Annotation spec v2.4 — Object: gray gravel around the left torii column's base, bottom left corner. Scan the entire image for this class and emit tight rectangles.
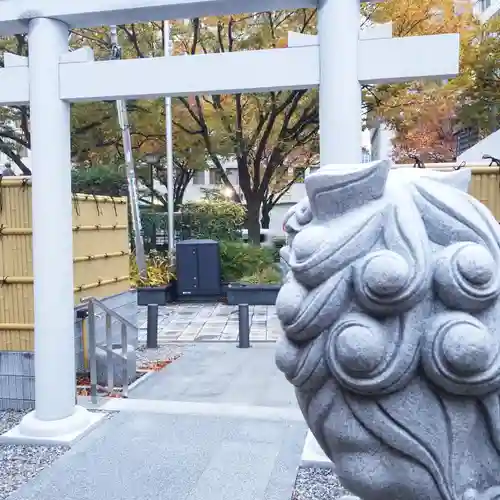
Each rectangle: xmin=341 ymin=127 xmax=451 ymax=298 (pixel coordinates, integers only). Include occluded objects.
xmin=0 ymin=411 xmax=68 ymax=500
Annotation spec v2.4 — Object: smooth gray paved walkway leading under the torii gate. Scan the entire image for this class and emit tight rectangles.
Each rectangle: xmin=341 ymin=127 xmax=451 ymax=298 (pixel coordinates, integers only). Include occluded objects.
xmin=10 ymin=342 xmax=306 ymax=500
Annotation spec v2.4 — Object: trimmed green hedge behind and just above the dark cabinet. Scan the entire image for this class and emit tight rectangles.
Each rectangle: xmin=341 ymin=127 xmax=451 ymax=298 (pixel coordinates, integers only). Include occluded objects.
xmin=179 ymin=200 xmax=246 ymax=241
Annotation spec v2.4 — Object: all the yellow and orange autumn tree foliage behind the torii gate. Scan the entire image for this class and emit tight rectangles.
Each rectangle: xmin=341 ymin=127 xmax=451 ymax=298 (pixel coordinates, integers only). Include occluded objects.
xmin=0 ymin=0 xmax=500 ymax=217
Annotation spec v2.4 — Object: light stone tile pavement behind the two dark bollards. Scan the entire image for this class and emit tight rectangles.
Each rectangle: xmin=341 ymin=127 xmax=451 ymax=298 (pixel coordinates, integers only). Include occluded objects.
xmin=138 ymin=303 xmax=281 ymax=344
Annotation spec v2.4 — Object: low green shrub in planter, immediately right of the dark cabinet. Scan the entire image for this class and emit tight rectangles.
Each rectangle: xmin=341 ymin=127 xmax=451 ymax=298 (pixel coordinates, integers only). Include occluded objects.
xmin=220 ymin=241 xmax=275 ymax=281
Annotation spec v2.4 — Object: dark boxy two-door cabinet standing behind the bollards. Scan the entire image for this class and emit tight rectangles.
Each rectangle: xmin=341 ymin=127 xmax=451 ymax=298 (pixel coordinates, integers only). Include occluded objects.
xmin=175 ymin=240 xmax=221 ymax=300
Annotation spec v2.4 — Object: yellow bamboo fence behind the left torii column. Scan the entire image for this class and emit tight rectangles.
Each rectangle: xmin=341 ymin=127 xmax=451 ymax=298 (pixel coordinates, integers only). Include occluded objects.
xmin=0 ymin=177 xmax=130 ymax=351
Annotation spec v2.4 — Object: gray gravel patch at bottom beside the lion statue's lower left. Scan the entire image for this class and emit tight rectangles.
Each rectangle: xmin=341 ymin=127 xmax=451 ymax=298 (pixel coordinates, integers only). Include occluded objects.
xmin=291 ymin=468 xmax=349 ymax=500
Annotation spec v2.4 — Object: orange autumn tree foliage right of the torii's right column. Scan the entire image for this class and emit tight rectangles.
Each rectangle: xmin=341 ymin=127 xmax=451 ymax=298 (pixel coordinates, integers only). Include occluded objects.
xmin=366 ymin=0 xmax=478 ymax=163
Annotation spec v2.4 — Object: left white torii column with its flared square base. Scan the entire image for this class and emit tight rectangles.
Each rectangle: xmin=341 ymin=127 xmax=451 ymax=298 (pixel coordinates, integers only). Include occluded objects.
xmin=2 ymin=18 xmax=101 ymax=443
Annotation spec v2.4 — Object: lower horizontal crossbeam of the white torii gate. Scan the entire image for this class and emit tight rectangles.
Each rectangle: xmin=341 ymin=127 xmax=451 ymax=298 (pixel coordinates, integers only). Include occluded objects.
xmin=0 ymin=34 xmax=456 ymax=105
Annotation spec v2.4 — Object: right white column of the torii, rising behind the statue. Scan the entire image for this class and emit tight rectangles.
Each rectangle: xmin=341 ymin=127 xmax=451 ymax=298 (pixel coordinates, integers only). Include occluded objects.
xmin=318 ymin=0 xmax=362 ymax=166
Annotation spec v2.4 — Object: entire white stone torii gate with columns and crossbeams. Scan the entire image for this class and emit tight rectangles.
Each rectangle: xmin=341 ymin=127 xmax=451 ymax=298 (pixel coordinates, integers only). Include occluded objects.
xmin=0 ymin=0 xmax=459 ymax=444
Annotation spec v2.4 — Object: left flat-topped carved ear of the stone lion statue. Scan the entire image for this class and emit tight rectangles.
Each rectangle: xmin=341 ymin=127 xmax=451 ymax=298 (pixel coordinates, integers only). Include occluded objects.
xmin=305 ymin=160 xmax=390 ymax=220
